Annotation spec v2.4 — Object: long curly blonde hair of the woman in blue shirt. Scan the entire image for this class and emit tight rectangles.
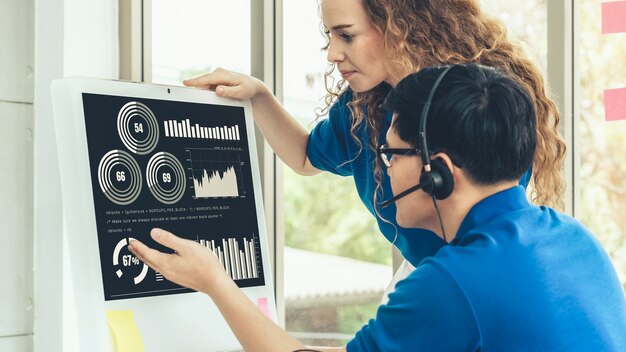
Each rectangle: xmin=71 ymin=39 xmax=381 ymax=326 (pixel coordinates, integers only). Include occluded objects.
xmin=321 ymin=0 xmax=566 ymax=209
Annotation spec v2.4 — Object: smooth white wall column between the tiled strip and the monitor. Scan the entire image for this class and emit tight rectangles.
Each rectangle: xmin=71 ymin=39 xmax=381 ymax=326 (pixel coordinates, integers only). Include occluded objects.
xmin=32 ymin=0 xmax=118 ymax=352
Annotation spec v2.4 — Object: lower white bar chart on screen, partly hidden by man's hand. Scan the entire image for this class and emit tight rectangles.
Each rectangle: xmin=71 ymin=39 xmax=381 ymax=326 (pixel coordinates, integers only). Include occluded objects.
xmin=198 ymin=237 xmax=259 ymax=280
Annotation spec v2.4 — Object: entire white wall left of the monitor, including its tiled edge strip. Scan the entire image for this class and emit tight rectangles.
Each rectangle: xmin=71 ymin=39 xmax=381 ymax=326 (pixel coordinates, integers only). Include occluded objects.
xmin=0 ymin=0 xmax=118 ymax=352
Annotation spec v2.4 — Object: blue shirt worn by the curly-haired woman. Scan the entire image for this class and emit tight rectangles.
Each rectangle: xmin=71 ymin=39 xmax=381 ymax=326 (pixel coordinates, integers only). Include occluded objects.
xmin=307 ymin=90 xmax=531 ymax=266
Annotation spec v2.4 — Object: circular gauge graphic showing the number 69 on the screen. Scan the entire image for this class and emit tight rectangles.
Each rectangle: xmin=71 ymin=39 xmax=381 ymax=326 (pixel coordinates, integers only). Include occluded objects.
xmin=146 ymin=152 xmax=186 ymax=204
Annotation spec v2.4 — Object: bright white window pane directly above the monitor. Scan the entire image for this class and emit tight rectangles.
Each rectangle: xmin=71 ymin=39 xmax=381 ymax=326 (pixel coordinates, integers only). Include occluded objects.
xmin=151 ymin=0 xmax=251 ymax=85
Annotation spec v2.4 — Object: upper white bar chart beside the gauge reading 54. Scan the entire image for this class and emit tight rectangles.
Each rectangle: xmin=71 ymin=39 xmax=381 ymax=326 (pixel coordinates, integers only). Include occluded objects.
xmin=163 ymin=119 xmax=240 ymax=141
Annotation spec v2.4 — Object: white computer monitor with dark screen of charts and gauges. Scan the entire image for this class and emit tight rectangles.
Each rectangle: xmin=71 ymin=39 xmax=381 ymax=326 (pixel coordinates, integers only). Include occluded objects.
xmin=52 ymin=78 xmax=276 ymax=351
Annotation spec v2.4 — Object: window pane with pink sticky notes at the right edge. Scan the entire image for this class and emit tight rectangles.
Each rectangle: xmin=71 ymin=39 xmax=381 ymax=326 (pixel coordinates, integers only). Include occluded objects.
xmin=575 ymin=0 xmax=626 ymax=284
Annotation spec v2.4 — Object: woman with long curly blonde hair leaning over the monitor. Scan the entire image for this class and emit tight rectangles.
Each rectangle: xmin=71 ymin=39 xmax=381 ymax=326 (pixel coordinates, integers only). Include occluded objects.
xmin=184 ymin=0 xmax=565 ymax=265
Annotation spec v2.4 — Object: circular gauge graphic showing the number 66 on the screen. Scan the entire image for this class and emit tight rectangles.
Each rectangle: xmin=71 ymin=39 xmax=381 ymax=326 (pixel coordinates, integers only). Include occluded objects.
xmin=98 ymin=149 xmax=142 ymax=205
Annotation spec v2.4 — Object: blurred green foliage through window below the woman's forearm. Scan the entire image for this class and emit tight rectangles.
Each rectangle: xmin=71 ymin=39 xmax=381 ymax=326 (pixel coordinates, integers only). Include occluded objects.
xmin=284 ymin=167 xmax=391 ymax=265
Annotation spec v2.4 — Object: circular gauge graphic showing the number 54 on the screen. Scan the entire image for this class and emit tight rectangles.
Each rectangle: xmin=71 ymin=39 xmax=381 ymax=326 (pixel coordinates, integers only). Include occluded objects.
xmin=117 ymin=101 xmax=159 ymax=155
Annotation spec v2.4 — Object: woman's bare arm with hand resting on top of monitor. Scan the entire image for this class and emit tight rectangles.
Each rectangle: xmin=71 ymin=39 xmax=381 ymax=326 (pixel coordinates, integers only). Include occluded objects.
xmin=184 ymin=68 xmax=320 ymax=175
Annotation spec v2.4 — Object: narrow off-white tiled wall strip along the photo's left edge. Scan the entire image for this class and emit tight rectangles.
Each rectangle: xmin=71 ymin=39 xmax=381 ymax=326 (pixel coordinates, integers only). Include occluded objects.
xmin=0 ymin=0 xmax=35 ymax=352
